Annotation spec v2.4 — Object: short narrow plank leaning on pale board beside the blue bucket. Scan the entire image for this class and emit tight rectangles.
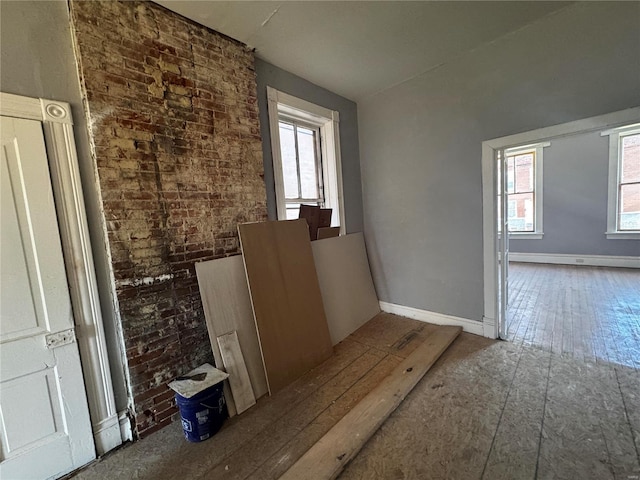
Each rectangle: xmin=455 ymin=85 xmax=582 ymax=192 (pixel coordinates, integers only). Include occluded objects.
xmin=218 ymin=330 xmax=256 ymax=415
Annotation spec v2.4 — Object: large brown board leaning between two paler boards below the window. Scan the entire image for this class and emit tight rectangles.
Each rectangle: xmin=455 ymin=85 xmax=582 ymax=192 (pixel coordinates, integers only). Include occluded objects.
xmin=238 ymin=220 xmax=333 ymax=393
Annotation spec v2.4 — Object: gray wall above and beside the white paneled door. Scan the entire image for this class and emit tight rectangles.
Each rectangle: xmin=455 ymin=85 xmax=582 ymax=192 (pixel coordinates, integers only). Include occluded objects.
xmin=0 ymin=0 xmax=128 ymax=411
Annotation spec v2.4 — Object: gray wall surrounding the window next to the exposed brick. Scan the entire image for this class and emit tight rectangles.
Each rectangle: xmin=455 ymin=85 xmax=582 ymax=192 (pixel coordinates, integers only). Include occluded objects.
xmin=256 ymin=59 xmax=363 ymax=233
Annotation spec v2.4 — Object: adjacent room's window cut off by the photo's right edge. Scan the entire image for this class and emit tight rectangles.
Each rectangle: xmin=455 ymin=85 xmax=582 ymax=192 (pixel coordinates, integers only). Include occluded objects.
xmin=602 ymin=124 xmax=640 ymax=239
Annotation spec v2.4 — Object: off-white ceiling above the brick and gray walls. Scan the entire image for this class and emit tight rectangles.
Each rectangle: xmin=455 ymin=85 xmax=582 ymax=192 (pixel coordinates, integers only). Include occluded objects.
xmin=156 ymin=0 xmax=572 ymax=101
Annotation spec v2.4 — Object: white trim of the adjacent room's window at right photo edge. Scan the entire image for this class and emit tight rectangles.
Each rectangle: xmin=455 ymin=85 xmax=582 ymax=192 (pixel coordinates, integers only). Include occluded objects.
xmin=600 ymin=123 xmax=640 ymax=240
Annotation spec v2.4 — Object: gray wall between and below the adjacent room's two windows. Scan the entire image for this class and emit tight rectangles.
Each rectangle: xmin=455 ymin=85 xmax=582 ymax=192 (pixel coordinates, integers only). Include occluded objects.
xmin=509 ymin=131 xmax=640 ymax=255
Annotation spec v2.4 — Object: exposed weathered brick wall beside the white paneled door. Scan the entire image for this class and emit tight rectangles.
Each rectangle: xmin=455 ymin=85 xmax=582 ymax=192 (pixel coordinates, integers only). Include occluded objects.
xmin=71 ymin=0 xmax=266 ymax=436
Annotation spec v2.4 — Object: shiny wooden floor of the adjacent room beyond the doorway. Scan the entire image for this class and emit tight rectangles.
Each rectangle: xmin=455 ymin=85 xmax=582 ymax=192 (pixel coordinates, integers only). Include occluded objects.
xmin=507 ymin=263 xmax=640 ymax=368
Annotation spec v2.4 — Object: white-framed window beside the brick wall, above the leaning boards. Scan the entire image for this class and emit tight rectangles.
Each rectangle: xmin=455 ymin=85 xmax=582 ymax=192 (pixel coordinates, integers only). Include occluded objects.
xmin=267 ymin=87 xmax=345 ymax=234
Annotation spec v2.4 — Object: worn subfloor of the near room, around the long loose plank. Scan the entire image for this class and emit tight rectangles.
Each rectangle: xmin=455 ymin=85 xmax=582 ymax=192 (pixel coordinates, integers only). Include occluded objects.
xmin=74 ymin=314 xmax=640 ymax=480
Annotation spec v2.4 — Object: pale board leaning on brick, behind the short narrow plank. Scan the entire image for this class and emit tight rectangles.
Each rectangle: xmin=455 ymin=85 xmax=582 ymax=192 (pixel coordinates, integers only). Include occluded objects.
xmin=196 ymin=255 xmax=269 ymax=416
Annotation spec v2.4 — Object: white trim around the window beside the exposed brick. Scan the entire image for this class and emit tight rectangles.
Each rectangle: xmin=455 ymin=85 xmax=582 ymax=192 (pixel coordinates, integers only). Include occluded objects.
xmin=267 ymin=86 xmax=346 ymax=235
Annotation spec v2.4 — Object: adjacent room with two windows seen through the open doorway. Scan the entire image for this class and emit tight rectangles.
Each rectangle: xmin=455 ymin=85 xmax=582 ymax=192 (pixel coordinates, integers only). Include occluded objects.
xmin=505 ymin=122 xmax=640 ymax=368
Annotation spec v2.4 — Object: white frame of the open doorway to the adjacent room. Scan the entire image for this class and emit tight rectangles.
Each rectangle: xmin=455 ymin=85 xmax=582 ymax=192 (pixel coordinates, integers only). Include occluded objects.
xmin=482 ymin=107 xmax=640 ymax=338
